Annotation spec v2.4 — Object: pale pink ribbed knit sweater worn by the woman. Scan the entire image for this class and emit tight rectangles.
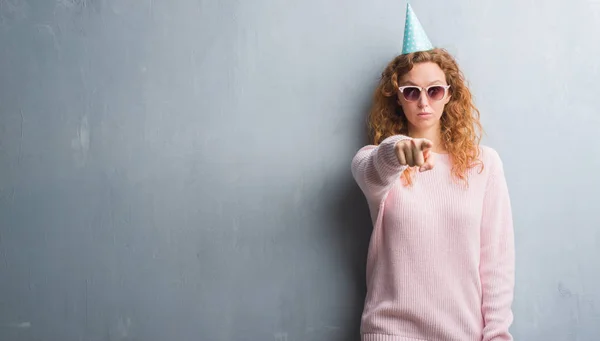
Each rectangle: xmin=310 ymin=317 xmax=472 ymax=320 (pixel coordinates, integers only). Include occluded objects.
xmin=352 ymin=135 xmax=515 ymax=341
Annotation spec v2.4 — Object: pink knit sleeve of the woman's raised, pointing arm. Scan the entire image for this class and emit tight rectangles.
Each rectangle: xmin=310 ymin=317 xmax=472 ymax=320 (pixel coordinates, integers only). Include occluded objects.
xmin=352 ymin=135 xmax=410 ymax=202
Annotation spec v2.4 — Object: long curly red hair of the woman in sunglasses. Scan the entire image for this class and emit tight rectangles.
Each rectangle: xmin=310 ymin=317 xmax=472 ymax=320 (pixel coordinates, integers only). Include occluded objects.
xmin=369 ymin=48 xmax=483 ymax=185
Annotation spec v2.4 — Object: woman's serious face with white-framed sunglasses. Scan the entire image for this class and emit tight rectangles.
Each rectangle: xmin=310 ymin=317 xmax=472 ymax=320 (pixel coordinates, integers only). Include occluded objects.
xmin=398 ymin=62 xmax=450 ymax=133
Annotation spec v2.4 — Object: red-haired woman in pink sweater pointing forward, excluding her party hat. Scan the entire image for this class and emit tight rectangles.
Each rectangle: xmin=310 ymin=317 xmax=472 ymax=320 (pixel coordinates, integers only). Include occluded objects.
xmin=352 ymin=5 xmax=515 ymax=341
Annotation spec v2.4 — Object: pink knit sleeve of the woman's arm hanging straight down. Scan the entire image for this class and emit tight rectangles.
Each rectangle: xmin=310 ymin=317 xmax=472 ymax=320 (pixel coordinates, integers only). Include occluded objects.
xmin=480 ymin=152 xmax=515 ymax=341
